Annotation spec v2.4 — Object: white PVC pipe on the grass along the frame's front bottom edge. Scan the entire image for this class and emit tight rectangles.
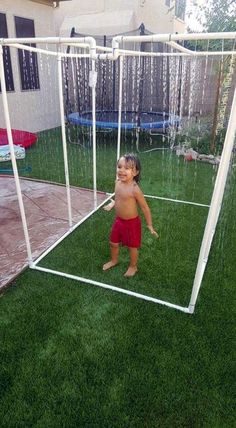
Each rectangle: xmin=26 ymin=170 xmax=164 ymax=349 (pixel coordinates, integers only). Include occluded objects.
xmin=31 ymin=266 xmax=190 ymax=314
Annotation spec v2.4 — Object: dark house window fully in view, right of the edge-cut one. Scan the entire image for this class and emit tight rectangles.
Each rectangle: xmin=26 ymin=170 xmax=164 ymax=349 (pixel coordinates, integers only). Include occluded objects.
xmin=15 ymin=16 xmax=40 ymax=90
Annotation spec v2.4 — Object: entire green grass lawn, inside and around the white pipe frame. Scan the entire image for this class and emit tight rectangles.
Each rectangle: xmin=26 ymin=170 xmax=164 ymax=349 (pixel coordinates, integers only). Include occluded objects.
xmin=0 ymin=132 xmax=236 ymax=428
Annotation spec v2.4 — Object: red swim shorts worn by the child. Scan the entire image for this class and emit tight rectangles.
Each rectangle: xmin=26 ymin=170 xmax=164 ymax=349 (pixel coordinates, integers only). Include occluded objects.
xmin=110 ymin=216 xmax=141 ymax=248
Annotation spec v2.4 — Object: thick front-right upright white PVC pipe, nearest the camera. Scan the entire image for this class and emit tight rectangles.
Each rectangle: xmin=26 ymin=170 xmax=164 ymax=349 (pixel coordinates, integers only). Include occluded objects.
xmin=189 ymin=89 xmax=236 ymax=313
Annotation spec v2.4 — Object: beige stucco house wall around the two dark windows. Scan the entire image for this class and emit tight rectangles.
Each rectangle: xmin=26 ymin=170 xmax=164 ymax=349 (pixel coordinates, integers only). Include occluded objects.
xmin=0 ymin=0 xmax=60 ymax=132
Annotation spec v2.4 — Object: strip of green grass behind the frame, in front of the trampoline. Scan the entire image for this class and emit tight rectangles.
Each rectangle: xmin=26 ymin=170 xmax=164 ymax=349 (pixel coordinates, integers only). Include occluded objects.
xmin=0 ymin=128 xmax=216 ymax=203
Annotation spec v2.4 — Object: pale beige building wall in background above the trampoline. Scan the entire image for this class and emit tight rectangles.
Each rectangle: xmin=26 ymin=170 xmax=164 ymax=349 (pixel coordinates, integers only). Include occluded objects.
xmin=55 ymin=0 xmax=185 ymax=36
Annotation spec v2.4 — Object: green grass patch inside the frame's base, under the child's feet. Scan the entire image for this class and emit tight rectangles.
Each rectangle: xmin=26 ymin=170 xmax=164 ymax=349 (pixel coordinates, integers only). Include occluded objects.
xmin=39 ymin=200 xmax=207 ymax=306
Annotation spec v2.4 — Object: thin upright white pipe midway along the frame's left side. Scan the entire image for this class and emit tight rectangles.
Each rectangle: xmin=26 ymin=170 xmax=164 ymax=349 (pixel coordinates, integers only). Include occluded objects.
xmin=57 ymin=55 xmax=72 ymax=227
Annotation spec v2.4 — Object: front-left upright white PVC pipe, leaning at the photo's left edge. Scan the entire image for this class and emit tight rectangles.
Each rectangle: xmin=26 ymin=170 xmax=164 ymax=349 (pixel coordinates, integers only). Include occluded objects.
xmin=0 ymin=45 xmax=33 ymax=266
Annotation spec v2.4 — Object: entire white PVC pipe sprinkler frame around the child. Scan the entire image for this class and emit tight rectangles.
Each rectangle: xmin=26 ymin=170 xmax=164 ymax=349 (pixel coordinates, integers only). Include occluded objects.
xmin=0 ymin=32 xmax=236 ymax=314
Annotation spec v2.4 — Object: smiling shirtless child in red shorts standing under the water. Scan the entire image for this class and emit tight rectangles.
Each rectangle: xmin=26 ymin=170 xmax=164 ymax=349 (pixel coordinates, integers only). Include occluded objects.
xmin=103 ymin=154 xmax=158 ymax=277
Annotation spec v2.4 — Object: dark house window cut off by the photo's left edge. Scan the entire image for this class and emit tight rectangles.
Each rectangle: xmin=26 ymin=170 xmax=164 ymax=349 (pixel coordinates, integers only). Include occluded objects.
xmin=0 ymin=13 xmax=15 ymax=91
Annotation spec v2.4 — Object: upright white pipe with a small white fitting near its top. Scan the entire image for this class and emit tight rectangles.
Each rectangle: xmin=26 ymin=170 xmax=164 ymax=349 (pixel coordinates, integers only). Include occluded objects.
xmin=90 ymin=59 xmax=98 ymax=209
